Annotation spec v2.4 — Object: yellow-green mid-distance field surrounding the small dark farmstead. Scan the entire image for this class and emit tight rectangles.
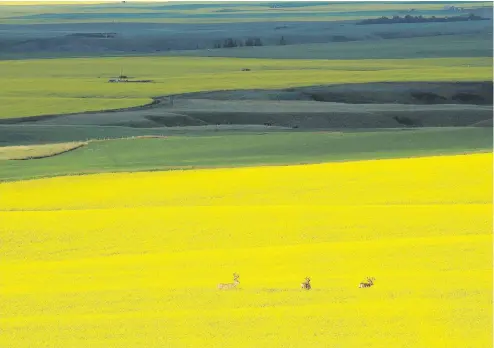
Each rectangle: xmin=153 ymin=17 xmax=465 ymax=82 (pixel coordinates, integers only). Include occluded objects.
xmin=0 ymin=57 xmax=492 ymax=118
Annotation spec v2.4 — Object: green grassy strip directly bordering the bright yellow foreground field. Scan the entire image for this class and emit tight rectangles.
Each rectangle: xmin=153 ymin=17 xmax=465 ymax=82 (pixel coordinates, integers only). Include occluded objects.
xmin=0 ymin=128 xmax=492 ymax=180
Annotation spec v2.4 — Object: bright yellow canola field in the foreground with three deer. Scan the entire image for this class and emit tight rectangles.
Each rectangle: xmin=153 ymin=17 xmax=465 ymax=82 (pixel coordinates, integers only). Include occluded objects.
xmin=0 ymin=153 xmax=492 ymax=348
